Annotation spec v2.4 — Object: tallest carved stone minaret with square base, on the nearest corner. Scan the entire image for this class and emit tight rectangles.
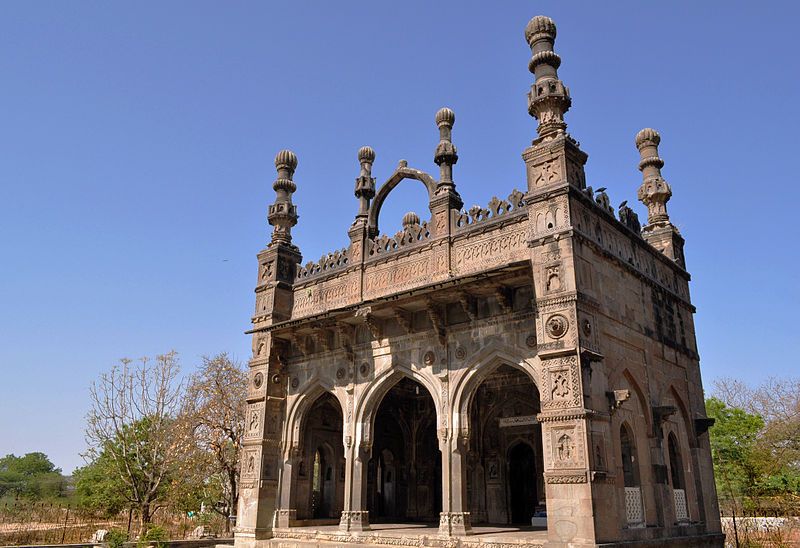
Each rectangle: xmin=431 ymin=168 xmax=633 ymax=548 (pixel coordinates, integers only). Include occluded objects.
xmin=522 ymin=15 xmax=587 ymax=198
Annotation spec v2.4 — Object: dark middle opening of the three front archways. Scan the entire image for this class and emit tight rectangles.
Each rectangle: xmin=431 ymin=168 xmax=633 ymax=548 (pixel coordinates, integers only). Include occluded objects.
xmin=367 ymin=378 xmax=442 ymax=523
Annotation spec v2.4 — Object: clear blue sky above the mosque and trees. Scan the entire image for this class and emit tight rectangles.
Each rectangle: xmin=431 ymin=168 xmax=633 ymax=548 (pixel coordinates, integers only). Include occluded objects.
xmin=0 ymin=1 xmax=800 ymax=471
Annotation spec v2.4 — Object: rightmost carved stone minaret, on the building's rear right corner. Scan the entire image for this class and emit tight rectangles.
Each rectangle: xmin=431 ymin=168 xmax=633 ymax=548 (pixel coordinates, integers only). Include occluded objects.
xmin=635 ymin=128 xmax=686 ymax=268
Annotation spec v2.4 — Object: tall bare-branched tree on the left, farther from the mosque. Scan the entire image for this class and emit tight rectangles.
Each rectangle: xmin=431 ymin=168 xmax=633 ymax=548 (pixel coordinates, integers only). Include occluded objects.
xmin=86 ymin=351 xmax=183 ymax=530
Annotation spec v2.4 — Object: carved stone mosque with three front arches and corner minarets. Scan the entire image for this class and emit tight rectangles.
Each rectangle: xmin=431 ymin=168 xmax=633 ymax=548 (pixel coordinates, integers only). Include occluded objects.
xmin=235 ymin=16 xmax=723 ymax=548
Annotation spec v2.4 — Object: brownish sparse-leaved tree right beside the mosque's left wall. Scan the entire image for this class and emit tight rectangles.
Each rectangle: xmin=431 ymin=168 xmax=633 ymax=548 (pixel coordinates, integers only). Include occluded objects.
xmin=181 ymin=353 xmax=247 ymax=522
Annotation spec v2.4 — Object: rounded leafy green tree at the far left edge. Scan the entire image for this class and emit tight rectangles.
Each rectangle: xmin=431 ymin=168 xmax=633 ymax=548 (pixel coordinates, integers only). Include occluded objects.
xmin=0 ymin=452 xmax=66 ymax=499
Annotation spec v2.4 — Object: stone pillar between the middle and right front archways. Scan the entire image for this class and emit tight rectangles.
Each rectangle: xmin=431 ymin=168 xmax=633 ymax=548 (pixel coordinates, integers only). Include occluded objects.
xmin=439 ymin=436 xmax=472 ymax=536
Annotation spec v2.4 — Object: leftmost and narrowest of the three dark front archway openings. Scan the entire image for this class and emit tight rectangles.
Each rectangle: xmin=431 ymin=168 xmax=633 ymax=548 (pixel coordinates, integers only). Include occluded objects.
xmin=295 ymin=393 xmax=345 ymax=523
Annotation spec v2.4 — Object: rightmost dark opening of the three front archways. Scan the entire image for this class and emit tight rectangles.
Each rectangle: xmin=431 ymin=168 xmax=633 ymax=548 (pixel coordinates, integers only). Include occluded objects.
xmin=467 ymin=365 xmax=546 ymax=525
